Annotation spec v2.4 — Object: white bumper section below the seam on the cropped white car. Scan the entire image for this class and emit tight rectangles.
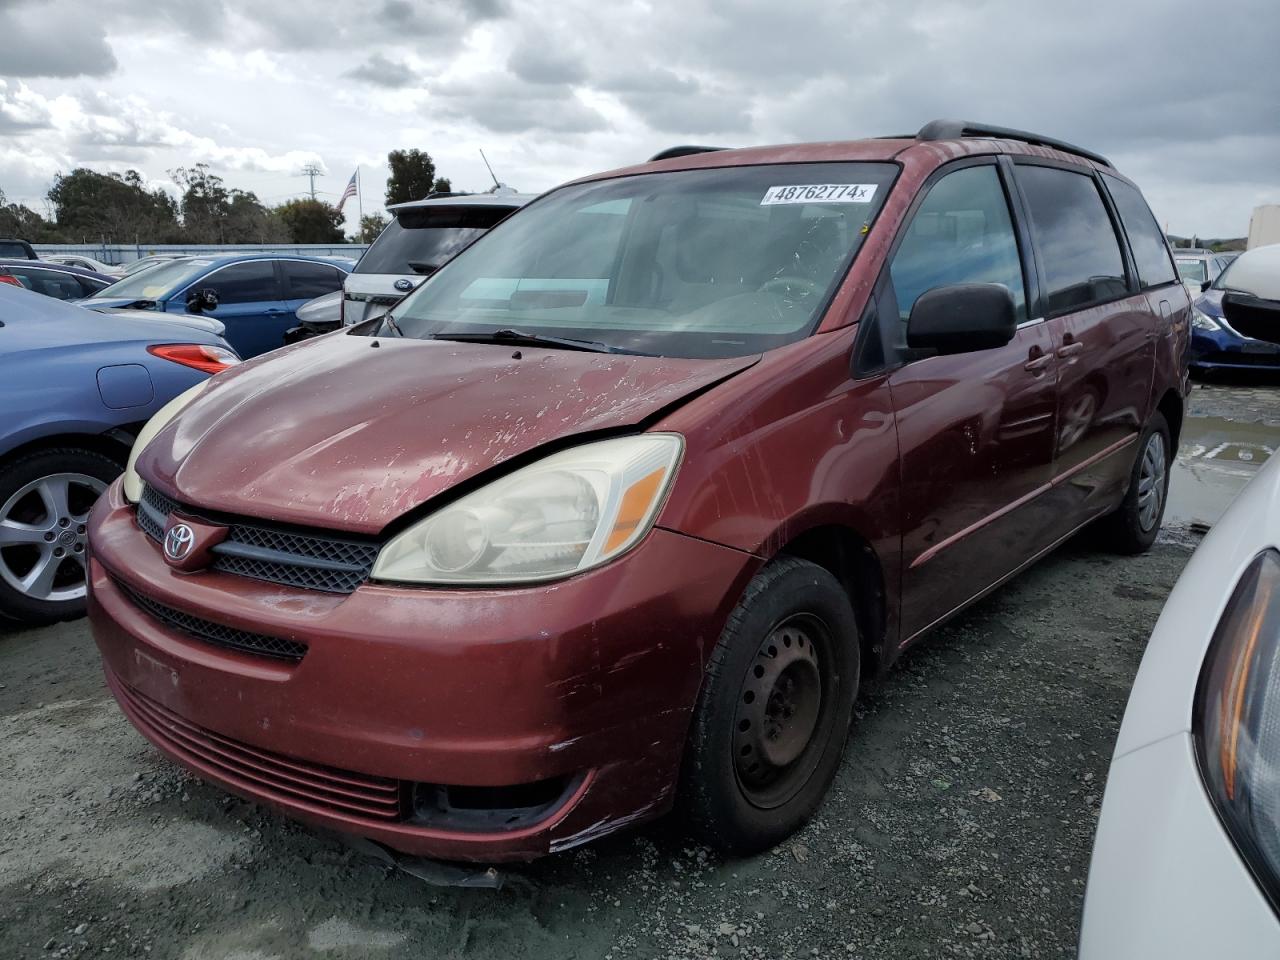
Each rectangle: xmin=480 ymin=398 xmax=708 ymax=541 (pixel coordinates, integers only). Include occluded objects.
xmin=1080 ymin=732 xmax=1280 ymax=960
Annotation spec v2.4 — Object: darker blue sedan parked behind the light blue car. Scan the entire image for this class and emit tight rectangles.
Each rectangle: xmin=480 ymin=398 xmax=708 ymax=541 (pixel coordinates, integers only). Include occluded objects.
xmin=82 ymin=253 xmax=347 ymax=360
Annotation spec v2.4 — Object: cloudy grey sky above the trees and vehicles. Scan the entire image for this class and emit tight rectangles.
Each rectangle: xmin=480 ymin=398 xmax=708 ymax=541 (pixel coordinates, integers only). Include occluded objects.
xmin=0 ymin=0 xmax=1280 ymax=237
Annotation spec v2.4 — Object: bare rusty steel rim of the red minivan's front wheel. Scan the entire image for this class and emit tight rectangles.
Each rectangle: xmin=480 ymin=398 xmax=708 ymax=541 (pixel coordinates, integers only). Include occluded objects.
xmin=733 ymin=614 xmax=835 ymax=809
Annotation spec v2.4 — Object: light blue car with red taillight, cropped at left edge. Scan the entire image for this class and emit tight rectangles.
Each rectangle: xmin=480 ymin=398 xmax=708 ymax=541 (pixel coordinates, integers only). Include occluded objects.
xmin=0 ymin=284 xmax=238 ymax=623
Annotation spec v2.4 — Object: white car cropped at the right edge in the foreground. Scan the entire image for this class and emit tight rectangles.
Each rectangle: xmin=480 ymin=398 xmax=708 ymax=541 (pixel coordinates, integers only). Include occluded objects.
xmin=1080 ymin=457 xmax=1280 ymax=960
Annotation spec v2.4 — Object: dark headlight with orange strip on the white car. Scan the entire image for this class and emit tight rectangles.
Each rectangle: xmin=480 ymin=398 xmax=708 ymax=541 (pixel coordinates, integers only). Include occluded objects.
xmin=1193 ymin=549 xmax=1280 ymax=905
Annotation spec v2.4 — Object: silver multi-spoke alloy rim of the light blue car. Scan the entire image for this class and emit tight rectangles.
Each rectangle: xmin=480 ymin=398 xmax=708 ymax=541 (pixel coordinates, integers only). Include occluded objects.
xmin=0 ymin=472 xmax=106 ymax=603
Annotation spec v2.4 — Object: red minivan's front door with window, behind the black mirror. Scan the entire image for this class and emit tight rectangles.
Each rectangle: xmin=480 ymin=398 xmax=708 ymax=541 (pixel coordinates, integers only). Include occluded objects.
xmin=888 ymin=163 xmax=1057 ymax=643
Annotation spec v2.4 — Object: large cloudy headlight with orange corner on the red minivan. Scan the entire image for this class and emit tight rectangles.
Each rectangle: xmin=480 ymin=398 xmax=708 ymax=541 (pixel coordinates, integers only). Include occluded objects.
xmin=372 ymin=434 xmax=684 ymax=584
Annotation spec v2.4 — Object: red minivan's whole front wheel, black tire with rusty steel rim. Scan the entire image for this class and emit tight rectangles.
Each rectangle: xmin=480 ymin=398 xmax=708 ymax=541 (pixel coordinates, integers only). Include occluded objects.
xmin=678 ymin=557 xmax=859 ymax=855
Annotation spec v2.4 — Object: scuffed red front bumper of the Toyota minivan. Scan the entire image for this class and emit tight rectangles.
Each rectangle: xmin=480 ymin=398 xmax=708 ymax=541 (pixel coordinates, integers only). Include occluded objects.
xmin=90 ymin=481 xmax=758 ymax=861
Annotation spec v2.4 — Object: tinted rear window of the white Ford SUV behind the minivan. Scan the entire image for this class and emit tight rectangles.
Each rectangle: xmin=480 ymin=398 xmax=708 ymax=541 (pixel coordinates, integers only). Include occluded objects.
xmin=355 ymin=207 xmax=511 ymax=276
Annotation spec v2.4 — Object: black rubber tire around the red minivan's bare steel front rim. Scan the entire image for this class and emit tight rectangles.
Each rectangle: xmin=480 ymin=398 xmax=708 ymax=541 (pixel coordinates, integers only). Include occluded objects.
xmin=677 ymin=557 xmax=860 ymax=856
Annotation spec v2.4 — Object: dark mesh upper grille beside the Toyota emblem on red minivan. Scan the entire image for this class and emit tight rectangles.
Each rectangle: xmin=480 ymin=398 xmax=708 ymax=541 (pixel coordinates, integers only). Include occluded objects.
xmin=138 ymin=486 xmax=379 ymax=594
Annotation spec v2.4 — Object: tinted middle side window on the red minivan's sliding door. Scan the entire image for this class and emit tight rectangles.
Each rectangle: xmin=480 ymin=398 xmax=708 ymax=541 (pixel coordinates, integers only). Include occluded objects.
xmin=1016 ymin=164 xmax=1129 ymax=314
